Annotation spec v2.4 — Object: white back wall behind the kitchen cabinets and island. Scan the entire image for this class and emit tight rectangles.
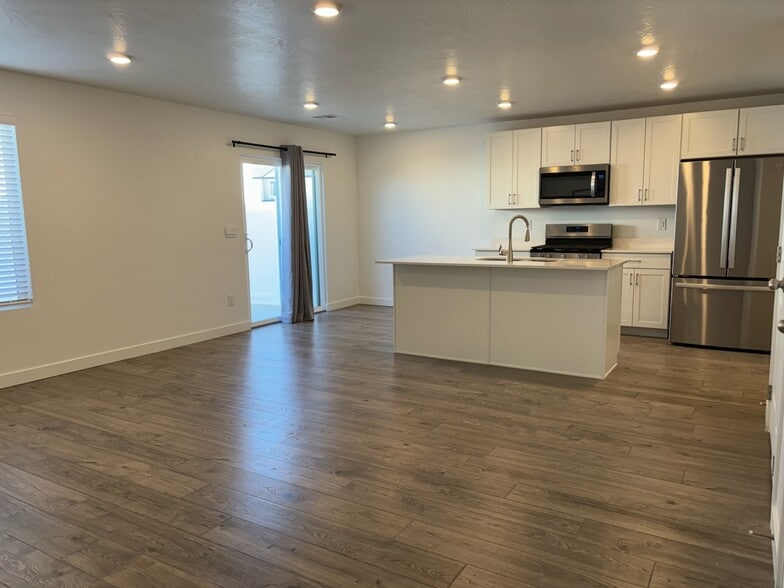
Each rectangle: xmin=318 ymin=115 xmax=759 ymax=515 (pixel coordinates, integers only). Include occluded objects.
xmin=357 ymin=94 xmax=784 ymax=304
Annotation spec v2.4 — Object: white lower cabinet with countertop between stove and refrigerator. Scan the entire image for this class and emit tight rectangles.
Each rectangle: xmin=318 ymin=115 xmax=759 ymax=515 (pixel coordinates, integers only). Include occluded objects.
xmin=602 ymin=253 xmax=670 ymax=330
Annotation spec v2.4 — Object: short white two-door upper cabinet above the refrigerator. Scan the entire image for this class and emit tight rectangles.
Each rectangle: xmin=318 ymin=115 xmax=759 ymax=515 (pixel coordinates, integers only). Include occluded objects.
xmin=681 ymin=106 xmax=784 ymax=159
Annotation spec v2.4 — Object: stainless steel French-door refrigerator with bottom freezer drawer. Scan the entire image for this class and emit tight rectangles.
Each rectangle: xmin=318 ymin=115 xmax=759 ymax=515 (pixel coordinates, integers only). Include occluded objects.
xmin=670 ymin=156 xmax=784 ymax=351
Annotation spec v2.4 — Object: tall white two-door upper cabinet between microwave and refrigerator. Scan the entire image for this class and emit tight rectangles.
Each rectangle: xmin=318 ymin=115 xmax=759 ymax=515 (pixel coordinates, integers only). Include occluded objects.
xmin=610 ymin=114 xmax=682 ymax=206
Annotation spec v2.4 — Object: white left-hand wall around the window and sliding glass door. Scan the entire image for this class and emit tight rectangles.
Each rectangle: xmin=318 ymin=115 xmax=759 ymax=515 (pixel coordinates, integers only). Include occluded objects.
xmin=0 ymin=72 xmax=357 ymax=387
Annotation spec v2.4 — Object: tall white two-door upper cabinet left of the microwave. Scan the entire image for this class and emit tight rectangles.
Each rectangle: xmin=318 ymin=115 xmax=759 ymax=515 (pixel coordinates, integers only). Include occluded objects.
xmin=490 ymin=129 xmax=542 ymax=209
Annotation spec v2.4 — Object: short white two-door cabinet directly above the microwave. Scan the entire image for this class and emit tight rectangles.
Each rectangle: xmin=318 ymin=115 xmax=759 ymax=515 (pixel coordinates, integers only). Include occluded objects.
xmin=542 ymin=122 xmax=610 ymax=167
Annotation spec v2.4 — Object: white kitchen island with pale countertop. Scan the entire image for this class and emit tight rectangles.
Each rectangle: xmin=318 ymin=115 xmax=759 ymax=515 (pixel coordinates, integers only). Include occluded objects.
xmin=377 ymin=256 xmax=623 ymax=379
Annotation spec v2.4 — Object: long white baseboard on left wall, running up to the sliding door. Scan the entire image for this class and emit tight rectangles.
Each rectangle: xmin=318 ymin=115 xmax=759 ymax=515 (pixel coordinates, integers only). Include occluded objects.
xmin=0 ymin=321 xmax=250 ymax=389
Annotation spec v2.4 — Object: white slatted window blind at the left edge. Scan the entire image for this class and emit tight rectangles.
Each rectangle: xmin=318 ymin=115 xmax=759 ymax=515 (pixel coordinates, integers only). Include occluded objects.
xmin=0 ymin=119 xmax=33 ymax=307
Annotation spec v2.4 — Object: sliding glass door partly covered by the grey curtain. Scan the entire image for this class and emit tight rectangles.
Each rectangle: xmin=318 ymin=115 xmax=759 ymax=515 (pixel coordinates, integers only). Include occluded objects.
xmin=242 ymin=157 xmax=323 ymax=326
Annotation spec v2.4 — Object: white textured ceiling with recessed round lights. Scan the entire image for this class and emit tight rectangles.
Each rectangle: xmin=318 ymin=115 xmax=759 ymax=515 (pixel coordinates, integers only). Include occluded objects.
xmin=0 ymin=0 xmax=784 ymax=134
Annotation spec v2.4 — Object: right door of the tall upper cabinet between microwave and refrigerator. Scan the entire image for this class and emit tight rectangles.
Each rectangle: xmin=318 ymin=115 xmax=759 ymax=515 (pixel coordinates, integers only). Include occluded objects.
xmin=644 ymin=114 xmax=683 ymax=204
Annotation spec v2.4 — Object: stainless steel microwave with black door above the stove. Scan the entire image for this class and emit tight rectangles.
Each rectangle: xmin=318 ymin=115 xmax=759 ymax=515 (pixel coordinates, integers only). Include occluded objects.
xmin=539 ymin=164 xmax=610 ymax=206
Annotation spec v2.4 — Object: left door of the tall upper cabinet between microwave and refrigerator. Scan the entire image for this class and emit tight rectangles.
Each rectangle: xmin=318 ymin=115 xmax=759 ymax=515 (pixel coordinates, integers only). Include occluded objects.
xmin=610 ymin=118 xmax=645 ymax=206
